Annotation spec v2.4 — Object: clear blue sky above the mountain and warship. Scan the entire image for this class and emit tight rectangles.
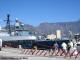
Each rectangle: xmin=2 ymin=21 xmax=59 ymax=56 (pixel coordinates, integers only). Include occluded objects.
xmin=0 ymin=0 xmax=80 ymax=26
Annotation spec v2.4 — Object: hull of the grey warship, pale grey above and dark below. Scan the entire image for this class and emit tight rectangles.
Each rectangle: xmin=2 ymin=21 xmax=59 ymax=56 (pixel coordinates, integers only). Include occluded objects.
xmin=0 ymin=36 xmax=36 ymax=48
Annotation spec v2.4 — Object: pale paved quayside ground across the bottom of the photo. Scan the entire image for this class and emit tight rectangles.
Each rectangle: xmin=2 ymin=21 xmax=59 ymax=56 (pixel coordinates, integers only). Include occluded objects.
xmin=0 ymin=48 xmax=80 ymax=60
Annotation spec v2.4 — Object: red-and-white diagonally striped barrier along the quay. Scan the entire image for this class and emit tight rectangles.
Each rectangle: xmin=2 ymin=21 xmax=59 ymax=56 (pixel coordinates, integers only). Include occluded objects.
xmin=22 ymin=48 xmax=80 ymax=59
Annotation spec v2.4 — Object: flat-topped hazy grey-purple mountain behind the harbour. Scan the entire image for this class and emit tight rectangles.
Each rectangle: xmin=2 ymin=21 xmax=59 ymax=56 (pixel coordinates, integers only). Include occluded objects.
xmin=25 ymin=20 xmax=80 ymax=35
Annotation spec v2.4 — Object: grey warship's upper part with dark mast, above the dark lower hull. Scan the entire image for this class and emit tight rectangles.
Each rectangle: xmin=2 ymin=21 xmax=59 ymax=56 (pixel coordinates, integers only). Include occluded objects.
xmin=0 ymin=14 xmax=36 ymax=41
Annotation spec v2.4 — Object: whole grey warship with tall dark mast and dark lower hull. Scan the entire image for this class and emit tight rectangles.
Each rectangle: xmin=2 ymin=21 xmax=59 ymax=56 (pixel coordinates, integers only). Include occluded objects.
xmin=0 ymin=14 xmax=37 ymax=48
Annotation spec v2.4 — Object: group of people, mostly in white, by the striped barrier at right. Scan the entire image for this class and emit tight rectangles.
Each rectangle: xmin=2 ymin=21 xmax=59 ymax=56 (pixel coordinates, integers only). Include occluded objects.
xmin=54 ymin=40 xmax=77 ymax=55
